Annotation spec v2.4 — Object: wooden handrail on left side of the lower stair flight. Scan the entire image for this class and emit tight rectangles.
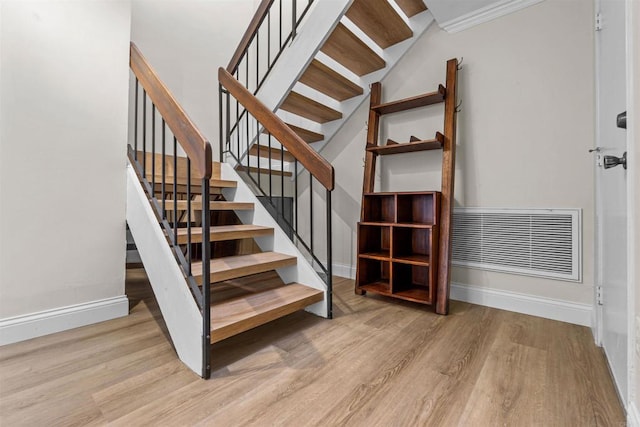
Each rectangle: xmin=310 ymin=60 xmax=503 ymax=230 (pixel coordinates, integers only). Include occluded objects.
xmin=129 ymin=42 xmax=213 ymax=179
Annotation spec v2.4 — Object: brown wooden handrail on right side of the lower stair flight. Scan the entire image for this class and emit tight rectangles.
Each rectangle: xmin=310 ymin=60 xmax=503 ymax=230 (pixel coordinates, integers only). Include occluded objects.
xmin=218 ymin=67 xmax=334 ymax=191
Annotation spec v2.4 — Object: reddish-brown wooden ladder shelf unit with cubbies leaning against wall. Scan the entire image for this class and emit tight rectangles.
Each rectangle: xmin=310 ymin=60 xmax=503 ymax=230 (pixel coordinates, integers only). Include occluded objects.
xmin=355 ymin=59 xmax=458 ymax=314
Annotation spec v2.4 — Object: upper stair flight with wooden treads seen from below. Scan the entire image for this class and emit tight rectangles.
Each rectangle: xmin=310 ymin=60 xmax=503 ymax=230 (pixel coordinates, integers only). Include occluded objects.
xmin=221 ymin=0 xmax=433 ymax=175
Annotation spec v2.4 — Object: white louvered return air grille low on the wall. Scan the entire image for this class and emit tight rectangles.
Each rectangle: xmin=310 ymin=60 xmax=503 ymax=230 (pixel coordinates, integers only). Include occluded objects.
xmin=452 ymin=208 xmax=581 ymax=281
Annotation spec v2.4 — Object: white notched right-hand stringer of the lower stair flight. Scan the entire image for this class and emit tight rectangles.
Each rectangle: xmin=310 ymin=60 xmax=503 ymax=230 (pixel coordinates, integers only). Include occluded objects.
xmin=220 ymin=163 xmax=331 ymax=317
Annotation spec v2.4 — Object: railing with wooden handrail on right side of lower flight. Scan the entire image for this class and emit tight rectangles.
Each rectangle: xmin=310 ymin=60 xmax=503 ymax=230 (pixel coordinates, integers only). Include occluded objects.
xmin=218 ymin=68 xmax=334 ymax=317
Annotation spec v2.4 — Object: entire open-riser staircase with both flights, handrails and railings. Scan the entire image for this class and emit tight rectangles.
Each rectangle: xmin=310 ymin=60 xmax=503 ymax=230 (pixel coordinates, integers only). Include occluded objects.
xmin=127 ymin=0 xmax=433 ymax=378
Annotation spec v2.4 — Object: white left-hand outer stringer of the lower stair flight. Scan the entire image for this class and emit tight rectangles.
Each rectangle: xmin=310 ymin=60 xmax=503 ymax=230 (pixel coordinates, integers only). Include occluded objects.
xmin=126 ymin=164 xmax=203 ymax=375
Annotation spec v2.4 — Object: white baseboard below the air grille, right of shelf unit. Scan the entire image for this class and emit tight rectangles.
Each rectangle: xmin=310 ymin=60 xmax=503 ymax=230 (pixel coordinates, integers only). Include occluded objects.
xmin=450 ymin=283 xmax=593 ymax=327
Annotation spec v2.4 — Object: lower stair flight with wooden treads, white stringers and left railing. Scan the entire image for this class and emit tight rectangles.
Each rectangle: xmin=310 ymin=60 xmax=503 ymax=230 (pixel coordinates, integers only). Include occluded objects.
xmin=127 ymin=43 xmax=333 ymax=378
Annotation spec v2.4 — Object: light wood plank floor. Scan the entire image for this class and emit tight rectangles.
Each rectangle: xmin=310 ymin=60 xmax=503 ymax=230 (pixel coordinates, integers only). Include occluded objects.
xmin=0 ymin=270 xmax=624 ymax=427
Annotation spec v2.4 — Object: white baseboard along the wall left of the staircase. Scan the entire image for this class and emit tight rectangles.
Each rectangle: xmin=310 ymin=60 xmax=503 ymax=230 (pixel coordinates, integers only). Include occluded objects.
xmin=0 ymin=295 xmax=129 ymax=345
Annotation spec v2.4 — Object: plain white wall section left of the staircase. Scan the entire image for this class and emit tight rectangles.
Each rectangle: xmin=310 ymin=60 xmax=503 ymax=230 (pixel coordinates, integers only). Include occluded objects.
xmin=0 ymin=0 xmax=131 ymax=320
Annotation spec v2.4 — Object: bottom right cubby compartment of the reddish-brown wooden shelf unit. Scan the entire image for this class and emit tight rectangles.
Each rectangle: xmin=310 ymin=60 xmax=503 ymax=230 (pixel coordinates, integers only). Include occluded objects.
xmin=392 ymin=263 xmax=433 ymax=304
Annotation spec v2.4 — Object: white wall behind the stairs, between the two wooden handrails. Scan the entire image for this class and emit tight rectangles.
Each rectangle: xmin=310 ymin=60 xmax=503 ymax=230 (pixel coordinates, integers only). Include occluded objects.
xmin=131 ymin=0 xmax=257 ymax=160
